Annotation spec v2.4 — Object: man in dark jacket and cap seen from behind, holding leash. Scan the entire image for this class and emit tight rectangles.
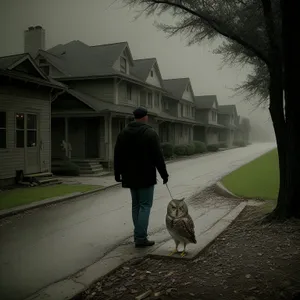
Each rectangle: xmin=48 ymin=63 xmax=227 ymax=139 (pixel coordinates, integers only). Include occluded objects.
xmin=114 ymin=107 xmax=169 ymax=248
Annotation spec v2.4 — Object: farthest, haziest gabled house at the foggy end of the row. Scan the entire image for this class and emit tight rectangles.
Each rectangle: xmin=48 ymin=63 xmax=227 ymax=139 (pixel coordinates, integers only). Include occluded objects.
xmin=218 ymin=105 xmax=238 ymax=147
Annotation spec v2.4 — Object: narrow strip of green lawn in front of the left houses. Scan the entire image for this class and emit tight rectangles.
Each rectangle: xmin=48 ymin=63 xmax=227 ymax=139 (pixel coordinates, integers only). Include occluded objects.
xmin=0 ymin=184 xmax=101 ymax=209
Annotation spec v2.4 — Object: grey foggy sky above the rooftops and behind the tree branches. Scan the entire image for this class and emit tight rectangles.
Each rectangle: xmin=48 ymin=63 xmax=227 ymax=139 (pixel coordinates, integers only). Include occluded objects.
xmin=0 ymin=0 xmax=271 ymax=134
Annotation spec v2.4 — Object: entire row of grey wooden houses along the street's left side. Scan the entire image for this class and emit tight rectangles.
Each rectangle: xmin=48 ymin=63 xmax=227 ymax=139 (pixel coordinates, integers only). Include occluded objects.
xmin=0 ymin=26 xmax=250 ymax=185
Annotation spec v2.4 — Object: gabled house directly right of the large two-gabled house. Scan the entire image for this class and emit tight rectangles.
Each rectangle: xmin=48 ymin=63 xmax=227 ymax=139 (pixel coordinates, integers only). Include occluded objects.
xmin=158 ymin=78 xmax=196 ymax=145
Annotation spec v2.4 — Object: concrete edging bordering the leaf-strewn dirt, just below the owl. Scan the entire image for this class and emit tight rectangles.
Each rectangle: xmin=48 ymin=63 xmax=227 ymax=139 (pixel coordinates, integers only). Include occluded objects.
xmin=26 ymin=202 xmax=246 ymax=300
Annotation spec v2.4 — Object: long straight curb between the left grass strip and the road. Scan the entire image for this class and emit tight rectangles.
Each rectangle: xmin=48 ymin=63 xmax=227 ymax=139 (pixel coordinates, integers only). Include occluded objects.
xmin=0 ymin=183 xmax=120 ymax=219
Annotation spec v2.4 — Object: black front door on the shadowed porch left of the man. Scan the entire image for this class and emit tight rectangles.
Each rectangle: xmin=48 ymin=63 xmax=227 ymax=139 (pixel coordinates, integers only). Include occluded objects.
xmin=85 ymin=118 xmax=99 ymax=158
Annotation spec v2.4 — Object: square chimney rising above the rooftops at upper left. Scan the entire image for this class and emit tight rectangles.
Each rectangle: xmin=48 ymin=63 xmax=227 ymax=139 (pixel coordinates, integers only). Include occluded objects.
xmin=24 ymin=25 xmax=45 ymax=58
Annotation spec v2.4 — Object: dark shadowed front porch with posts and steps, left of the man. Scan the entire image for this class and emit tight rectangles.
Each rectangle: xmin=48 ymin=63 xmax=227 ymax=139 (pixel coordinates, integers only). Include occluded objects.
xmin=51 ymin=113 xmax=129 ymax=176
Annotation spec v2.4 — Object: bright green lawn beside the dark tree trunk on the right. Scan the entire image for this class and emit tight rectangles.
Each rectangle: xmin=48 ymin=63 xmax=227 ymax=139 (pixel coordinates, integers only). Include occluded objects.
xmin=222 ymin=149 xmax=279 ymax=200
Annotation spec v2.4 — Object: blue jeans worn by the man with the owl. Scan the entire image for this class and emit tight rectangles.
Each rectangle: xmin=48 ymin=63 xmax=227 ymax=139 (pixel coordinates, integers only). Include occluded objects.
xmin=130 ymin=185 xmax=154 ymax=243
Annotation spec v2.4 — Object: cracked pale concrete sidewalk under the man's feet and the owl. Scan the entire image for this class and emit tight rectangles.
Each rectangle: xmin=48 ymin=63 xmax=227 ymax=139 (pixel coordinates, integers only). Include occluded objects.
xmin=26 ymin=190 xmax=246 ymax=300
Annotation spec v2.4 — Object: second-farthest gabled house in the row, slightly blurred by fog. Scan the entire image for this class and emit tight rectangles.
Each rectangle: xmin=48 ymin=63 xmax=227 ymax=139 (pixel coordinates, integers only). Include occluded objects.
xmin=194 ymin=95 xmax=224 ymax=145
